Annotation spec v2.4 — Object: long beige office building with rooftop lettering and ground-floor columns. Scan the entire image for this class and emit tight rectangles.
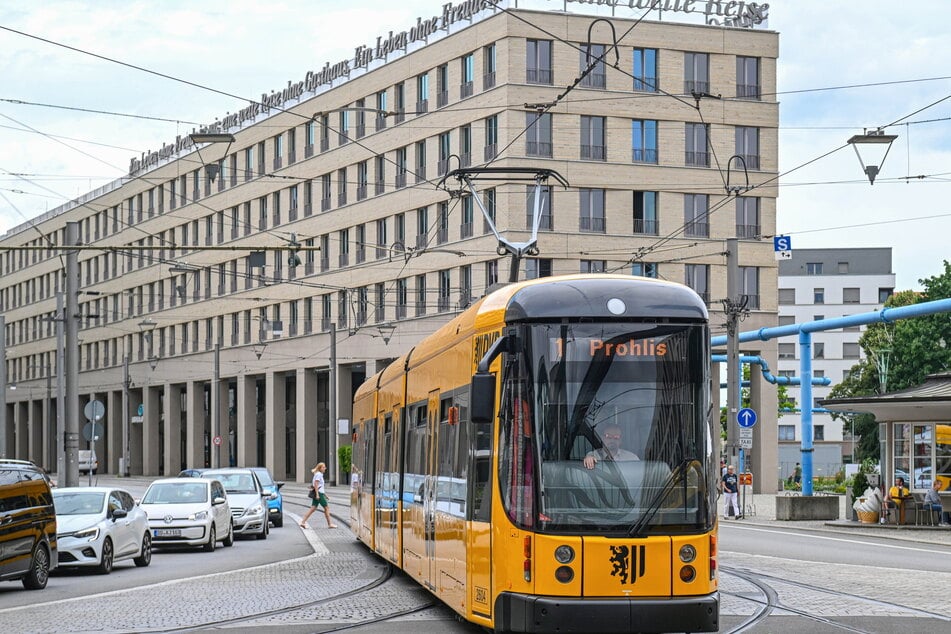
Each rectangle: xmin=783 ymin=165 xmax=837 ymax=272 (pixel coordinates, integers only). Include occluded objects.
xmin=0 ymin=2 xmax=779 ymax=481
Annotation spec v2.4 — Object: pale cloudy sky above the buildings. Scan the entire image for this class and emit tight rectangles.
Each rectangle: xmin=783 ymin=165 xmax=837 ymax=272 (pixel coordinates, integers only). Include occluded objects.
xmin=0 ymin=0 xmax=951 ymax=290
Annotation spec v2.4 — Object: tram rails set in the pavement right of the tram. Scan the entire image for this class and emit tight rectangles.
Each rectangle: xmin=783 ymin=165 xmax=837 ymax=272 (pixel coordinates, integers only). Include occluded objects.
xmin=720 ymin=566 xmax=951 ymax=634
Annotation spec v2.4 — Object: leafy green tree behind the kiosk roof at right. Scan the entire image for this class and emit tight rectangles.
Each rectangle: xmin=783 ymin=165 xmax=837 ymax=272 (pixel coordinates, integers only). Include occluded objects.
xmin=829 ymin=260 xmax=951 ymax=462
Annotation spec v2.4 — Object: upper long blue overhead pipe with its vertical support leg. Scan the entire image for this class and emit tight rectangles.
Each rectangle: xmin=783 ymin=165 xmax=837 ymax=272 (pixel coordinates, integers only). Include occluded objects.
xmin=710 ymin=299 xmax=951 ymax=495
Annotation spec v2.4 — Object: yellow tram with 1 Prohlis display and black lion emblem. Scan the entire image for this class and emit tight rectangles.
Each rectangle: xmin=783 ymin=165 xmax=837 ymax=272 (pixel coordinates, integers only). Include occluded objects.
xmin=350 ymin=275 xmax=719 ymax=632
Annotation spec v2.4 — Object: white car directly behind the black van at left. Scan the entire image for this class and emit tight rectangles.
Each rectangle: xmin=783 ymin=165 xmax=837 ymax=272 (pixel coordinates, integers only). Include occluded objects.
xmin=53 ymin=487 xmax=152 ymax=575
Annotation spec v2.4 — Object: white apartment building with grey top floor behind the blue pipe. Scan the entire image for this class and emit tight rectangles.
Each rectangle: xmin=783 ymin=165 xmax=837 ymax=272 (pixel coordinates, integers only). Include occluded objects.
xmin=778 ymin=248 xmax=895 ymax=477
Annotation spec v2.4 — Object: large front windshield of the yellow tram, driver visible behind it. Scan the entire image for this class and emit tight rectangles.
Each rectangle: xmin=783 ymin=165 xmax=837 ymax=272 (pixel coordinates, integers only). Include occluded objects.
xmin=499 ymin=323 xmax=718 ymax=535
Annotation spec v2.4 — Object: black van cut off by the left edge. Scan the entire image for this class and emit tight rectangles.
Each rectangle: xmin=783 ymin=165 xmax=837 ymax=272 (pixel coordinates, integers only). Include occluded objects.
xmin=0 ymin=459 xmax=58 ymax=590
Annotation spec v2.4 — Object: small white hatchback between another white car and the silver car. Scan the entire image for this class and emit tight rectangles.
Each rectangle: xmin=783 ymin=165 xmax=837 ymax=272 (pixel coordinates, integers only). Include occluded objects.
xmin=139 ymin=478 xmax=234 ymax=552
